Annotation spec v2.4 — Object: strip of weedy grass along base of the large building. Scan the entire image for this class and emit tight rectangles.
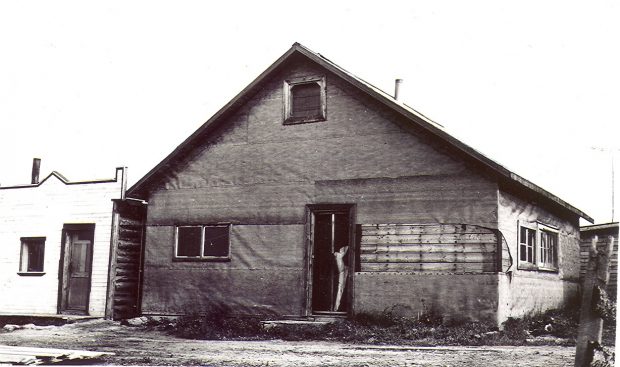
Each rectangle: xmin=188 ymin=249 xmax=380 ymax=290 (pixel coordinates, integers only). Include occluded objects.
xmin=160 ymin=302 xmax=615 ymax=346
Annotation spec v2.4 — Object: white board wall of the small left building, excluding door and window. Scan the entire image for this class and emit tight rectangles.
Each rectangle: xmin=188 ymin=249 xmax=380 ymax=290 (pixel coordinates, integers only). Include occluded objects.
xmin=0 ymin=169 xmax=123 ymax=316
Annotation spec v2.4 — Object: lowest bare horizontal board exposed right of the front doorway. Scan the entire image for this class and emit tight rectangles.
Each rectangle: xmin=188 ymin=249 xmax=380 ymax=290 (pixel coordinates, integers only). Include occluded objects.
xmin=361 ymin=262 xmax=496 ymax=273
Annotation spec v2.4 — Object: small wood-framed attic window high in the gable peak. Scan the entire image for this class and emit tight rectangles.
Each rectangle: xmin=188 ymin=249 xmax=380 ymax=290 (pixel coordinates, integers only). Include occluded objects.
xmin=284 ymin=76 xmax=326 ymax=124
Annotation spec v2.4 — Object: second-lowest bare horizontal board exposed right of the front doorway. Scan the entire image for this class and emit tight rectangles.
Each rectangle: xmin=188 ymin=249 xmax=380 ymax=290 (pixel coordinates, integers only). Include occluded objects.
xmin=360 ymin=252 xmax=495 ymax=263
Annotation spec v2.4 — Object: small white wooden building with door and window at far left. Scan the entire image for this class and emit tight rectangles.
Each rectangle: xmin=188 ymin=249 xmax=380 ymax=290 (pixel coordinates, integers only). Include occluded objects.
xmin=0 ymin=159 xmax=126 ymax=316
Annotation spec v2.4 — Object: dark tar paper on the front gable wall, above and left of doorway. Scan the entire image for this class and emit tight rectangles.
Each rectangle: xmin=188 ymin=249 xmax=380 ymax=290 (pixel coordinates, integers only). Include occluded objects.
xmin=142 ymin=59 xmax=497 ymax=315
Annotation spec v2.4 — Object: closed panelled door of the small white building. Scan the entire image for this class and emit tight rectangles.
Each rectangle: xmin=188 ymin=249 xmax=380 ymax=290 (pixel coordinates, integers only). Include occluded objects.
xmin=59 ymin=224 xmax=95 ymax=315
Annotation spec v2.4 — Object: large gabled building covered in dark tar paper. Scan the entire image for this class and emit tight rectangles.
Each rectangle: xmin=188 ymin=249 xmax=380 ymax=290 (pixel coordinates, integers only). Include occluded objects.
xmin=128 ymin=44 xmax=592 ymax=322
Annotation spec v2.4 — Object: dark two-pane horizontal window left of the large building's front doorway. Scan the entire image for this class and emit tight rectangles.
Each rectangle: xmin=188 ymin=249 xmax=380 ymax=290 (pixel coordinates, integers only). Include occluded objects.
xmin=174 ymin=224 xmax=230 ymax=261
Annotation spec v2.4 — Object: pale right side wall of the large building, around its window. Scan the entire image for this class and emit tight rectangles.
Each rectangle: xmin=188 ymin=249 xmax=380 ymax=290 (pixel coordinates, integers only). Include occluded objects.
xmin=498 ymin=190 xmax=579 ymax=322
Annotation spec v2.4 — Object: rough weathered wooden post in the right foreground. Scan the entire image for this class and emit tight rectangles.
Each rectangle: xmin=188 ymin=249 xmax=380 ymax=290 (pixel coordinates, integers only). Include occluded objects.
xmin=575 ymin=236 xmax=614 ymax=367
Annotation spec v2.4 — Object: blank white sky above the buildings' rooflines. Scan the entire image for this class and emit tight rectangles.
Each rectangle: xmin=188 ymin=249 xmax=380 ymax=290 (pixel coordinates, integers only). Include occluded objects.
xmin=0 ymin=0 xmax=620 ymax=223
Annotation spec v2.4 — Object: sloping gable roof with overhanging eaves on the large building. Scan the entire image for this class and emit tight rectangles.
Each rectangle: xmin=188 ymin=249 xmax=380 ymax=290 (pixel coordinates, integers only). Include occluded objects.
xmin=127 ymin=43 xmax=594 ymax=223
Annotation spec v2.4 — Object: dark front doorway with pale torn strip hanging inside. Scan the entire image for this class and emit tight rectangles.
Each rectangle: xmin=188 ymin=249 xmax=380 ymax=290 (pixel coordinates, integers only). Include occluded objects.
xmin=311 ymin=208 xmax=353 ymax=313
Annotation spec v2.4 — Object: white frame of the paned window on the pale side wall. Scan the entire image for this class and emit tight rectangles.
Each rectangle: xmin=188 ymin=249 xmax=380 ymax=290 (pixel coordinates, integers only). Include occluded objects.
xmin=517 ymin=222 xmax=560 ymax=273
